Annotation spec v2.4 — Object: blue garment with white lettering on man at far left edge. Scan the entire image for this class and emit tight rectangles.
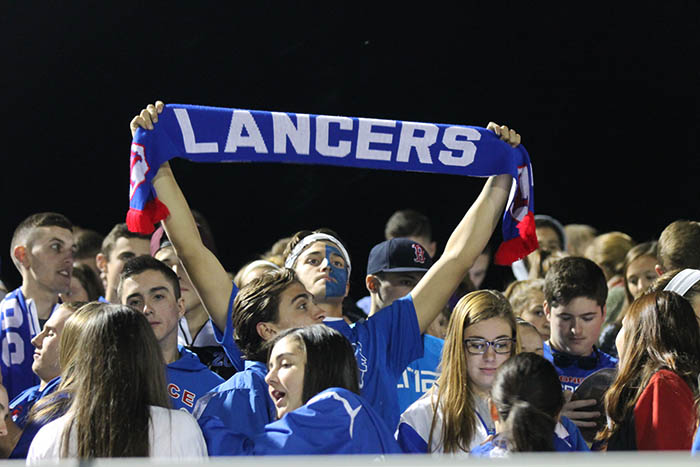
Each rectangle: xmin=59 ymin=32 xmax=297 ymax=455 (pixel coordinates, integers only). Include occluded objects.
xmin=0 ymin=288 xmax=41 ymax=400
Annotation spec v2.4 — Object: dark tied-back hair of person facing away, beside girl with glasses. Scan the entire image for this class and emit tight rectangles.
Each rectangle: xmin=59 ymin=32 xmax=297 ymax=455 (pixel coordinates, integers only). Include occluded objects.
xmin=491 ymin=352 xmax=564 ymax=452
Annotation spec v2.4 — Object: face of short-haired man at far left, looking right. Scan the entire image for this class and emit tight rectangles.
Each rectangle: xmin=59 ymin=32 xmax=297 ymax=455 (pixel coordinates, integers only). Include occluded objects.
xmin=22 ymin=226 xmax=75 ymax=294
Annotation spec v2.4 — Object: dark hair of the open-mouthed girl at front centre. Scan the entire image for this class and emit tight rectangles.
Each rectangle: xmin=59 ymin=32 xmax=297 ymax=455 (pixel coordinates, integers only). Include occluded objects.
xmin=268 ymin=324 xmax=360 ymax=404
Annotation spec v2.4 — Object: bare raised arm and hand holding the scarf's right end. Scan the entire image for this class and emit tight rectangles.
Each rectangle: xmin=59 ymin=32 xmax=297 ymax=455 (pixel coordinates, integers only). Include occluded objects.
xmin=411 ymin=123 xmax=520 ymax=333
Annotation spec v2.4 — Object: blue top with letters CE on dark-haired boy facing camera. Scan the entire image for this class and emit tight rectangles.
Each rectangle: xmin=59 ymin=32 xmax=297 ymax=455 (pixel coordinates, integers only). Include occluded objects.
xmin=165 ymin=346 xmax=224 ymax=413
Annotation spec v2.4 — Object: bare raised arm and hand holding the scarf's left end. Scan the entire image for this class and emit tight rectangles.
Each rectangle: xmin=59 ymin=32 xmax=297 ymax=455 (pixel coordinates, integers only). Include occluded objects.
xmin=130 ymin=101 xmax=233 ymax=332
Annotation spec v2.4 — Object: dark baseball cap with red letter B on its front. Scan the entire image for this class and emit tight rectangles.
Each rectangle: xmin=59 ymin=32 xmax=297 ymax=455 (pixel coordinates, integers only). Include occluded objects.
xmin=367 ymin=238 xmax=433 ymax=274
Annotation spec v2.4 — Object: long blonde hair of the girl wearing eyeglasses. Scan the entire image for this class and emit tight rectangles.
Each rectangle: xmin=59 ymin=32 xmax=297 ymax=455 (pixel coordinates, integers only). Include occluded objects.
xmin=428 ymin=290 xmax=519 ymax=453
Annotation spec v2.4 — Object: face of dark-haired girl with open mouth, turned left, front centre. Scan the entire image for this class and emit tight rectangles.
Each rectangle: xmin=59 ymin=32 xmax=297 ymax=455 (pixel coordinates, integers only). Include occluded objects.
xmin=265 ymin=336 xmax=306 ymax=418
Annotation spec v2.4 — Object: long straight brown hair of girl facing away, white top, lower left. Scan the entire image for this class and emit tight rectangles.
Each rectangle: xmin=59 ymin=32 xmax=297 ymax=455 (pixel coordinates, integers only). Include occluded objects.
xmin=61 ymin=304 xmax=169 ymax=458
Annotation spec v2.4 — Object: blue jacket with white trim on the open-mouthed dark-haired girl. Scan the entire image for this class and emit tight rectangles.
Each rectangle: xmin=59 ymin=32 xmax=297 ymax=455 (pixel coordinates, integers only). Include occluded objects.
xmin=200 ymin=388 xmax=400 ymax=456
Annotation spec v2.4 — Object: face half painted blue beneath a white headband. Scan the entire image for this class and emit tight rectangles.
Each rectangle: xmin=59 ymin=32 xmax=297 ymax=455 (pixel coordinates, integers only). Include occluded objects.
xmin=294 ymin=241 xmax=349 ymax=302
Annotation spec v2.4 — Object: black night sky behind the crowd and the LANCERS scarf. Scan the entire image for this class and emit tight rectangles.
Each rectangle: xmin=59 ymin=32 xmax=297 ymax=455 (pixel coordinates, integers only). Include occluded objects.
xmin=0 ymin=1 xmax=700 ymax=297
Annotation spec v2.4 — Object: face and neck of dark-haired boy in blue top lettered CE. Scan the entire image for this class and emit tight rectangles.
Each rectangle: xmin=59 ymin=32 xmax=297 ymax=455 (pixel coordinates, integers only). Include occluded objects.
xmin=121 ymin=269 xmax=185 ymax=347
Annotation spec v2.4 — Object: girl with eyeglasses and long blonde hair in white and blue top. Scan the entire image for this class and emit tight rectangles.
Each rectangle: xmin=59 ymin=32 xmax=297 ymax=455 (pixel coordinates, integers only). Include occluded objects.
xmin=396 ymin=290 xmax=517 ymax=456
